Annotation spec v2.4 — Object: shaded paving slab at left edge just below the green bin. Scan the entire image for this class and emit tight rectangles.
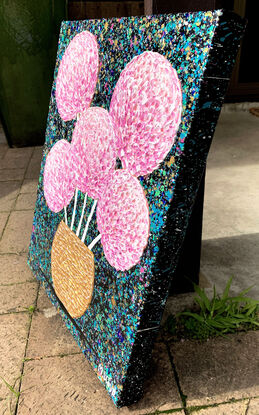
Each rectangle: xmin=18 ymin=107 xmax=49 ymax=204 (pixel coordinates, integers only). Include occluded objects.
xmin=0 ymin=147 xmax=33 ymax=169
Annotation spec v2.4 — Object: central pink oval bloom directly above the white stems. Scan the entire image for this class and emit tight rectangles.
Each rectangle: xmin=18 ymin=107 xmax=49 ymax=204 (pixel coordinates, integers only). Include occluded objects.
xmin=72 ymin=107 xmax=116 ymax=199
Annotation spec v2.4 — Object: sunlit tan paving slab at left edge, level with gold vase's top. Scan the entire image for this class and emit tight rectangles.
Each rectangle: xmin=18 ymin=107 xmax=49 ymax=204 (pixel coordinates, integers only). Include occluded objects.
xmin=0 ymin=210 xmax=34 ymax=253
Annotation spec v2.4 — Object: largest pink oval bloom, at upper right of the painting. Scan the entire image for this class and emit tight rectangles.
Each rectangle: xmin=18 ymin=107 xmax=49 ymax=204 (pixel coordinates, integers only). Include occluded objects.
xmin=110 ymin=51 xmax=182 ymax=176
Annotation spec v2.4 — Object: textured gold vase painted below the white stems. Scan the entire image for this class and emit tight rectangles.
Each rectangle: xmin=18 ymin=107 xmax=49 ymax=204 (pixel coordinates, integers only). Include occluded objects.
xmin=51 ymin=221 xmax=94 ymax=318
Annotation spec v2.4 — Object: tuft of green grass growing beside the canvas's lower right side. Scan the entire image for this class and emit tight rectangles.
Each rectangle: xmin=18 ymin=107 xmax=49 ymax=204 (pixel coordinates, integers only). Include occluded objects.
xmin=165 ymin=277 xmax=259 ymax=340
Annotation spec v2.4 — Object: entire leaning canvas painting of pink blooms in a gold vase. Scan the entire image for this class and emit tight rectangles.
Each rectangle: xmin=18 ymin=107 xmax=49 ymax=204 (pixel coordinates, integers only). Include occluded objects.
xmin=28 ymin=10 xmax=244 ymax=407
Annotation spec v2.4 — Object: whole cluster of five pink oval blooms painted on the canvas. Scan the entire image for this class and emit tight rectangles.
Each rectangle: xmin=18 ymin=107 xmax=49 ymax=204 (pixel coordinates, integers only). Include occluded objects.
xmin=48 ymin=45 xmax=182 ymax=271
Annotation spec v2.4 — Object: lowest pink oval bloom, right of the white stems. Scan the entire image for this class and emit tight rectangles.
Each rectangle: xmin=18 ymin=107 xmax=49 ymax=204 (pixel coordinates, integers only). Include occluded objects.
xmin=97 ymin=170 xmax=150 ymax=271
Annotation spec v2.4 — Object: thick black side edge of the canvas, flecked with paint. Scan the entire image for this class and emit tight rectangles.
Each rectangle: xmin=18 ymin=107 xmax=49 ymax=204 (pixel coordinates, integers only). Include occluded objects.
xmin=117 ymin=11 xmax=246 ymax=407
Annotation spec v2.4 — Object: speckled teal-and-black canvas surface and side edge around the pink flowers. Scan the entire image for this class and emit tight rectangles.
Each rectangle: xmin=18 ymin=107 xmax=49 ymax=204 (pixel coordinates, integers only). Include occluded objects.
xmin=29 ymin=11 xmax=246 ymax=406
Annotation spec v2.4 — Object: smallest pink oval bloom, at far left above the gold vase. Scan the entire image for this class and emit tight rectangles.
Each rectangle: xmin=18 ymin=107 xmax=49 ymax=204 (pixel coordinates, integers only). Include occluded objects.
xmin=43 ymin=140 xmax=75 ymax=212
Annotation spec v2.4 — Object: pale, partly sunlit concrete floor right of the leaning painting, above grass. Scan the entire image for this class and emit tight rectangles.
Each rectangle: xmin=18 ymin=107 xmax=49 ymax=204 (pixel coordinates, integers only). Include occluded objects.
xmin=201 ymin=111 xmax=259 ymax=298
